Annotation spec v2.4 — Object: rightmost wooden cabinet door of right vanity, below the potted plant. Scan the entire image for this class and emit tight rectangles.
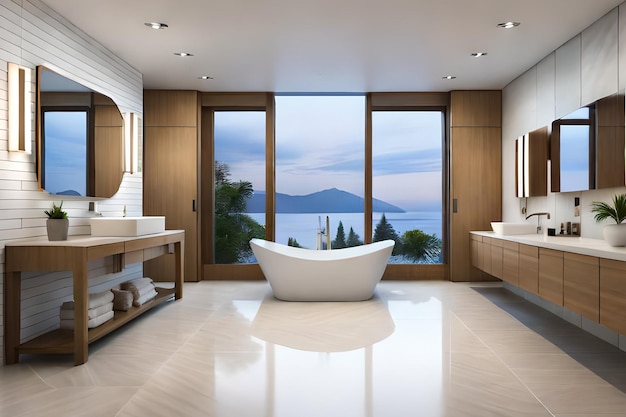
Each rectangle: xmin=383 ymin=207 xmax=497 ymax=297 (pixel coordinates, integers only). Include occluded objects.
xmin=600 ymin=259 xmax=626 ymax=334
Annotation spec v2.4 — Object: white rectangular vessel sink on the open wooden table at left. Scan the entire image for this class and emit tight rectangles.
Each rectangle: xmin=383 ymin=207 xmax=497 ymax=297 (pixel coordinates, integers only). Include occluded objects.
xmin=89 ymin=216 xmax=165 ymax=236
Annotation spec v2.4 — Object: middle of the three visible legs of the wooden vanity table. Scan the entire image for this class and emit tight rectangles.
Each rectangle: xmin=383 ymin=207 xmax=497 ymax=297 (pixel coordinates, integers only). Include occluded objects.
xmin=72 ymin=251 xmax=89 ymax=365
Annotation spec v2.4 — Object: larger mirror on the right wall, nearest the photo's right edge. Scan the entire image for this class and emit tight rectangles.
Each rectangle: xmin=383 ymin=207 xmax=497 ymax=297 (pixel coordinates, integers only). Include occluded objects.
xmin=550 ymin=92 xmax=626 ymax=192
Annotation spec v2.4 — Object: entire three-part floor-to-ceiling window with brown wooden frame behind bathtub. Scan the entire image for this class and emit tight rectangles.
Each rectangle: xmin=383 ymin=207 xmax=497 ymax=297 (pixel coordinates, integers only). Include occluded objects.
xmin=201 ymin=93 xmax=448 ymax=279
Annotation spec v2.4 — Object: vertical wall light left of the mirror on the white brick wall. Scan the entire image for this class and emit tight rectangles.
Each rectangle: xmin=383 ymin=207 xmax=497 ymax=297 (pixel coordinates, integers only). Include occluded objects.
xmin=8 ymin=62 xmax=32 ymax=153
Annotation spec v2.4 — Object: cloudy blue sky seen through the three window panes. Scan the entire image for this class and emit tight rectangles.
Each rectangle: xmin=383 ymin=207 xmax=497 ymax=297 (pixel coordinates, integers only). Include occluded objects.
xmin=215 ymin=95 xmax=442 ymax=211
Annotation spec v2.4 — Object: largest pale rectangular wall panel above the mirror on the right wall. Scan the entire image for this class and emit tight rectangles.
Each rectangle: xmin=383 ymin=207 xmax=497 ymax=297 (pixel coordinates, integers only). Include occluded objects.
xmin=580 ymin=8 xmax=619 ymax=106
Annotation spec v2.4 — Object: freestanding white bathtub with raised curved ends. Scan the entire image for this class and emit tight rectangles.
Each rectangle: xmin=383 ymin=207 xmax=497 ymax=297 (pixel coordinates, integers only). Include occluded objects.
xmin=250 ymin=239 xmax=394 ymax=301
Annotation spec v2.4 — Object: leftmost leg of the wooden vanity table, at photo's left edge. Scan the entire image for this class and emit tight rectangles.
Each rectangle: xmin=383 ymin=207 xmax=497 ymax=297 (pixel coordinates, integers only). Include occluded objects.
xmin=4 ymin=271 xmax=22 ymax=365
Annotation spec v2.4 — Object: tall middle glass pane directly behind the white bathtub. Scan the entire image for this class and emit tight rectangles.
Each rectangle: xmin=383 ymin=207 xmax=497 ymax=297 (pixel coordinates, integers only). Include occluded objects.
xmin=275 ymin=95 xmax=365 ymax=249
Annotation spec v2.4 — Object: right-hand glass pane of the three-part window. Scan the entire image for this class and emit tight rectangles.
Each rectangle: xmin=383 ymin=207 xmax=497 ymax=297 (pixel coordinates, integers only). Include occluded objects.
xmin=372 ymin=111 xmax=444 ymax=263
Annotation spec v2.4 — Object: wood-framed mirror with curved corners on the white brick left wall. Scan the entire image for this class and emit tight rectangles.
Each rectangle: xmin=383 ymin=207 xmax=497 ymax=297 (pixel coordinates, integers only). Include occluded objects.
xmin=36 ymin=66 xmax=124 ymax=198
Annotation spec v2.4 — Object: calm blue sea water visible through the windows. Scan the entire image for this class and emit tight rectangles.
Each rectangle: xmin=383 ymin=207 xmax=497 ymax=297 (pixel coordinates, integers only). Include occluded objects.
xmin=248 ymin=211 xmax=442 ymax=249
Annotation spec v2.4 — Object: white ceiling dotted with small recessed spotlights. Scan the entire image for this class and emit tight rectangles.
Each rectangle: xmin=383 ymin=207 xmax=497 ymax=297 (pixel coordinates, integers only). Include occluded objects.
xmin=43 ymin=0 xmax=623 ymax=92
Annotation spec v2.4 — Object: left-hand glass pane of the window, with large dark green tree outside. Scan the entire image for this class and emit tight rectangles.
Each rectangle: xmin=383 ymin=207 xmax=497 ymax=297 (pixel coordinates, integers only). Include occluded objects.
xmin=213 ymin=111 xmax=265 ymax=264
